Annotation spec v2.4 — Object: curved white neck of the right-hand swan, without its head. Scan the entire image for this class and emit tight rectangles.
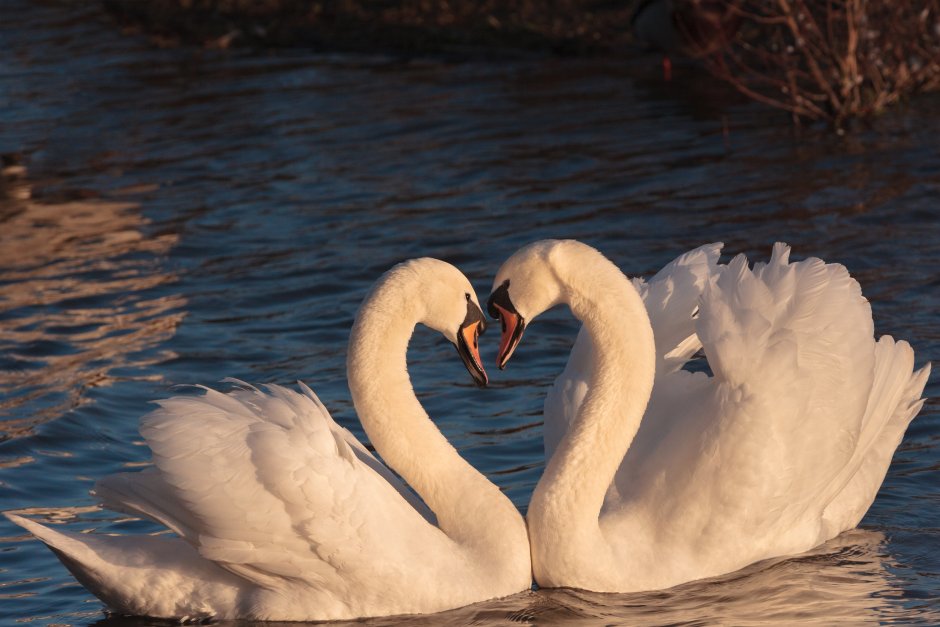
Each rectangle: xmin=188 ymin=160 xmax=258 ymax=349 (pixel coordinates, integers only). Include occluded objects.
xmin=529 ymin=254 xmax=656 ymax=543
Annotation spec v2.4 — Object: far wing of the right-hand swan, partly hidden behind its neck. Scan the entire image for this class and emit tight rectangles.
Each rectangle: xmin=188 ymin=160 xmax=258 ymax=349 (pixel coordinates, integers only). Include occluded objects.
xmin=543 ymin=242 xmax=722 ymax=460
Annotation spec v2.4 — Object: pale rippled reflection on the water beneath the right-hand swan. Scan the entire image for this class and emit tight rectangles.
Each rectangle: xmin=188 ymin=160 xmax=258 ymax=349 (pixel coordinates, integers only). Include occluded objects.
xmin=533 ymin=529 xmax=916 ymax=625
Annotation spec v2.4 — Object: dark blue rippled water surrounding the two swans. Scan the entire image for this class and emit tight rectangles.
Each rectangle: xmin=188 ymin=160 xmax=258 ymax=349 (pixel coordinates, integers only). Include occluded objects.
xmin=0 ymin=0 xmax=940 ymax=627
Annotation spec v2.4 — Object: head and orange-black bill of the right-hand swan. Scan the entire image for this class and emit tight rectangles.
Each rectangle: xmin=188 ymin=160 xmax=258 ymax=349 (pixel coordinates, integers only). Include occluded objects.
xmin=486 ymin=240 xmax=568 ymax=370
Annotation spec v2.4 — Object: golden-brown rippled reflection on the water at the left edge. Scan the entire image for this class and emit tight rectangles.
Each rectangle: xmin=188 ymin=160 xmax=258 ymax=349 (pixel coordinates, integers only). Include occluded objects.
xmin=0 ymin=172 xmax=185 ymax=441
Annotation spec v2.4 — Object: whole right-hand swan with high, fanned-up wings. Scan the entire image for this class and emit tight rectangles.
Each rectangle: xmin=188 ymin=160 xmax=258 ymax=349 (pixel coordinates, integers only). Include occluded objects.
xmin=487 ymin=241 xmax=929 ymax=592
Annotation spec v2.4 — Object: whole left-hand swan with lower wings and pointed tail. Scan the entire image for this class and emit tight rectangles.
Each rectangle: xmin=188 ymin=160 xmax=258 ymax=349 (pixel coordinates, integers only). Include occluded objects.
xmin=7 ymin=258 xmax=532 ymax=620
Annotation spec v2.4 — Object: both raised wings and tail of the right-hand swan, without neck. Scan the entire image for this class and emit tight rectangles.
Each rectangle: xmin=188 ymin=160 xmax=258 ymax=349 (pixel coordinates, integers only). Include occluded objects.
xmin=545 ymin=244 xmax=929 ymax=564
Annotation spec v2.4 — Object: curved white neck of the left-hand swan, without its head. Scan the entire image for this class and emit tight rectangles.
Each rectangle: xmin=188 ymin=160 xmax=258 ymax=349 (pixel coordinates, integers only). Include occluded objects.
xmin=347 ymin=281 xmax=528 ymax=560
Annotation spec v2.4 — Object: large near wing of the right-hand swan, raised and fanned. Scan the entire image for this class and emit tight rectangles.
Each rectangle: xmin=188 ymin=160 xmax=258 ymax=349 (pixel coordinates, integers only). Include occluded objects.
xmin=617 ymin=244 xmax=875 ymax=544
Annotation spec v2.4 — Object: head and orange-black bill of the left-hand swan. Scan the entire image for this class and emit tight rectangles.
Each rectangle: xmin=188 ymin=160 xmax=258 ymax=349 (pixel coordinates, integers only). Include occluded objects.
xmin=401 ymin=257 xmax=488 ymax=387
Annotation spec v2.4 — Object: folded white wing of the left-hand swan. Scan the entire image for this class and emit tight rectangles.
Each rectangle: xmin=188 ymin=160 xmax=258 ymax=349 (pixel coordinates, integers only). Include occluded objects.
xmin=96 ymin=385 xmax=450 ymax=590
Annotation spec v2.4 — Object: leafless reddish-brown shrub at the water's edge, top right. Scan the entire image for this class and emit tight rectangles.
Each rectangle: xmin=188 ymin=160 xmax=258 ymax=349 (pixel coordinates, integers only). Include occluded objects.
xmin=700 ymin=0 xmax=940 ymax=127
